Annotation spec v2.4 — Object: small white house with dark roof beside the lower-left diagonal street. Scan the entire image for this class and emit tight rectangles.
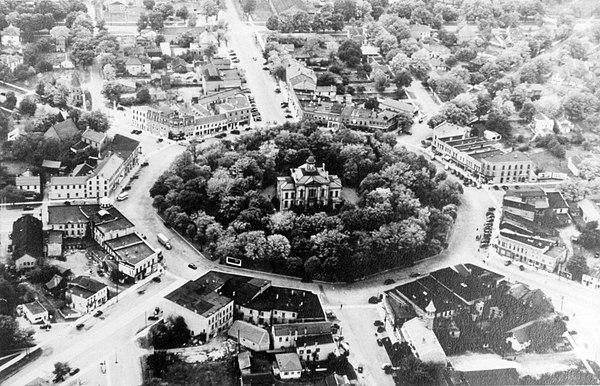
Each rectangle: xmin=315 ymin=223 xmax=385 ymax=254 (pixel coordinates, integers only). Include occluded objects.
xmin=65 ymin=276 xmax=108 ymax=314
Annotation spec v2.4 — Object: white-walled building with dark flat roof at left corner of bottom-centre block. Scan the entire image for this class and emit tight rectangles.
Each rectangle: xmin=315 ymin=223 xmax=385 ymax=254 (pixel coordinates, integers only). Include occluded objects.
xmin=161 ymin=272 xmax=233 ymax=339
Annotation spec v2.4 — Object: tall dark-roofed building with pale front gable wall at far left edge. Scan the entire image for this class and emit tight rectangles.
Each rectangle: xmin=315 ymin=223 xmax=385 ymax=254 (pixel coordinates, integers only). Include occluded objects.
xmin=11 ymin=214 xmax=44 ymax=271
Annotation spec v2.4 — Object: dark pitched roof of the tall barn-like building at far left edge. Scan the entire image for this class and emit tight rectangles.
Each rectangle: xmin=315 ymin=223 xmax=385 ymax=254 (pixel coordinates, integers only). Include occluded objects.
xmin=12 ymin=214 xmax=44 ymax=260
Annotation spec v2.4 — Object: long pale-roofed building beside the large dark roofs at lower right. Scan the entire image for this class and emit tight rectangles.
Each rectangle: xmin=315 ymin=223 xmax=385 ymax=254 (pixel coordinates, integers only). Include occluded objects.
xmin=400 ymin=318 xmax=448 ymax=365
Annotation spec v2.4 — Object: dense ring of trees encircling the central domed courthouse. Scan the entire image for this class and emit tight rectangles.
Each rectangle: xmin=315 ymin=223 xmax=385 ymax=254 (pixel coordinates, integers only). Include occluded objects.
xmin=150 ymin=121 xmax=462 ymax=281
